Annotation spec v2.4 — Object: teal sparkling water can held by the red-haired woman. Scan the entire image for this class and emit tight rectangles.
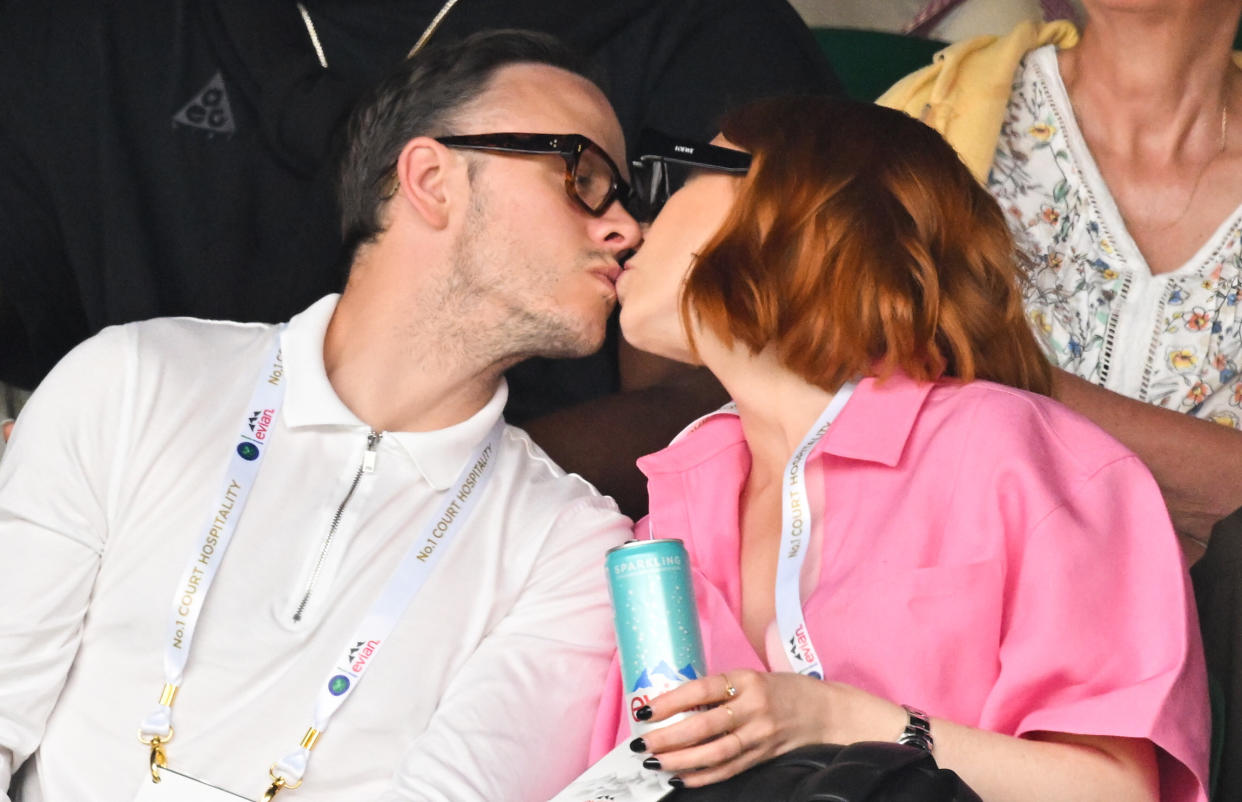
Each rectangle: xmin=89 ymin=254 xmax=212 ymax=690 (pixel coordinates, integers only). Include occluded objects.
xmin=605 ymin=539 xmax=707 ymax=735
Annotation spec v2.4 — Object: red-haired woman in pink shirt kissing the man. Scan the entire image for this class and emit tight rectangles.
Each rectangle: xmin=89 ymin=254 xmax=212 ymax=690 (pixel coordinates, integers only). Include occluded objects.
xmin=594 ymin=98 xmax=1208 ymax=802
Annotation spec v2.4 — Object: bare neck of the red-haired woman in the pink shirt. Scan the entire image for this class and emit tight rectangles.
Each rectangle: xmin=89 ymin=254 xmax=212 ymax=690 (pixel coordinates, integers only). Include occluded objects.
xmin=700 ymin=345 xmax=833 ymax=484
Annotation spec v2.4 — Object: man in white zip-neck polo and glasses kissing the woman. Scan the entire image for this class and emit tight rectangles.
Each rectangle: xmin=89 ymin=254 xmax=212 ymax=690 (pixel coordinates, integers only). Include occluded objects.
xmin=0 ymin=32 xmax=640 ymax=802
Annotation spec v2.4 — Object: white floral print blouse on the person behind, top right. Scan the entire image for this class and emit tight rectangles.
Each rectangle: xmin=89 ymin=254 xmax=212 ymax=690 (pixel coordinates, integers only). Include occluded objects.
xmin=987 ymin=45 xmax=1242 ymax=428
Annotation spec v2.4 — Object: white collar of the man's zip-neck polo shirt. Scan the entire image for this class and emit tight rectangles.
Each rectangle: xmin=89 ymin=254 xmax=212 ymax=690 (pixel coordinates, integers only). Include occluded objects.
xmin=281 ymin=294 xmax=509 ymax=490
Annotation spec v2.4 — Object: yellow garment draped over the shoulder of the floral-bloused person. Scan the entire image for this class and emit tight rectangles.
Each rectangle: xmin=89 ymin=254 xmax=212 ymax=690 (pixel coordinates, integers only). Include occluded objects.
xmin=876 ymin=20 xmax=1078 ymax=181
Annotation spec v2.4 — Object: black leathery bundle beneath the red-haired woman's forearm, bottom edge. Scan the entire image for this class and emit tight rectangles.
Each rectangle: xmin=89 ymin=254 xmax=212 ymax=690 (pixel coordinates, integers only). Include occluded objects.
xmin=664 ymin=741 xmax=981 ymax=802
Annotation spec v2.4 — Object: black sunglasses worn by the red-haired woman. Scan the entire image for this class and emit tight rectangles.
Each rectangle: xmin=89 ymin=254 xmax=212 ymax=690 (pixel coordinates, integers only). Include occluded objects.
xmin=631 ymin=129 xmax=750 ymax=220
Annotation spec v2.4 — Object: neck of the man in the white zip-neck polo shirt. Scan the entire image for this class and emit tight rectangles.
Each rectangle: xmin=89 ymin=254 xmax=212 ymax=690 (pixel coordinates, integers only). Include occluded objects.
xmin=323 ymin=243 xmax=515 ymax=432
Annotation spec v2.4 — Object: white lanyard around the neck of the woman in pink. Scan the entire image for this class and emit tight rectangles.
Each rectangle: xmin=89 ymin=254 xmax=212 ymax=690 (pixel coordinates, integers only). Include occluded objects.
xmin=652 ymin=381 xmax=857 ymax=679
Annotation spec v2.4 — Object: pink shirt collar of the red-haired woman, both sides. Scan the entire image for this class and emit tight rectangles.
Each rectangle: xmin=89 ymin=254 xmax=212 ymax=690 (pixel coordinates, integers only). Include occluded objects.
xmin=638 ymin=374 xmax=935 ymax=478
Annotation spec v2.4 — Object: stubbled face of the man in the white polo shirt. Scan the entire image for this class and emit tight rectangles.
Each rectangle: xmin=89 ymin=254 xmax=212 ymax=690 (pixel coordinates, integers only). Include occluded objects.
xmin=452 ymin=65 xmax=641 ymax=356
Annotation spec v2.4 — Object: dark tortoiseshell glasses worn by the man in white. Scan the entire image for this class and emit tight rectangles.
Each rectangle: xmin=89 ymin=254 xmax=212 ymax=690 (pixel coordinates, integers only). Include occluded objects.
xmin=422 ymin=134 xmax=633 ymax=217
